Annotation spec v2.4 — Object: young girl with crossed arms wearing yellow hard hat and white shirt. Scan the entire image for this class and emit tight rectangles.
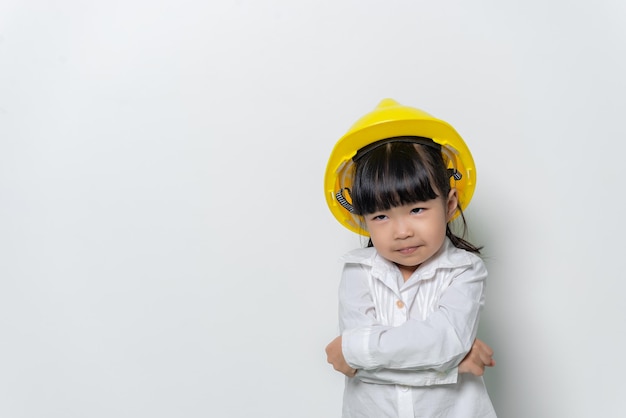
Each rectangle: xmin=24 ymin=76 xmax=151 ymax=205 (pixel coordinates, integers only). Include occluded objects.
xmin=325 ymin=99 xmax=495 ymax=418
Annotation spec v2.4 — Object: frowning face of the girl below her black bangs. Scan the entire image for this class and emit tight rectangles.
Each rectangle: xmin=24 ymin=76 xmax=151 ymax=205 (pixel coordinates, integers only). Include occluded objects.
xmin=364 ymin=189 xmax=458 ymax=281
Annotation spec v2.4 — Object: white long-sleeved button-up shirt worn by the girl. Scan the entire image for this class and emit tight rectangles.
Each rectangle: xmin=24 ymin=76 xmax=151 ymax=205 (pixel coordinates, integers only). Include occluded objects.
xmin=339 ymin=239 xmax=496 ymax=418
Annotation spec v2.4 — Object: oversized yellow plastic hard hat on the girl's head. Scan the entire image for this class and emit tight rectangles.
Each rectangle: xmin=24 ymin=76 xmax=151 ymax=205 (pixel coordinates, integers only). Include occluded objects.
xmin=324 ymin=99 xmax=476 ymax=236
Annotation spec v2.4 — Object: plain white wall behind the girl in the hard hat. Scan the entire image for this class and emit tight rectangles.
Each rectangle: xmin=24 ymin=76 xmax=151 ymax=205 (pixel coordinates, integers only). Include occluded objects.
xmin=0 ymin=0 xmax=626 ymax=418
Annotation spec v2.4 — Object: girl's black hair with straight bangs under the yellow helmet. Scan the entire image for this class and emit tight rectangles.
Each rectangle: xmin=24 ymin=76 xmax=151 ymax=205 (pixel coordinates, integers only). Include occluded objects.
xmin=351 ymin=137 xmax=481 ymax=254
